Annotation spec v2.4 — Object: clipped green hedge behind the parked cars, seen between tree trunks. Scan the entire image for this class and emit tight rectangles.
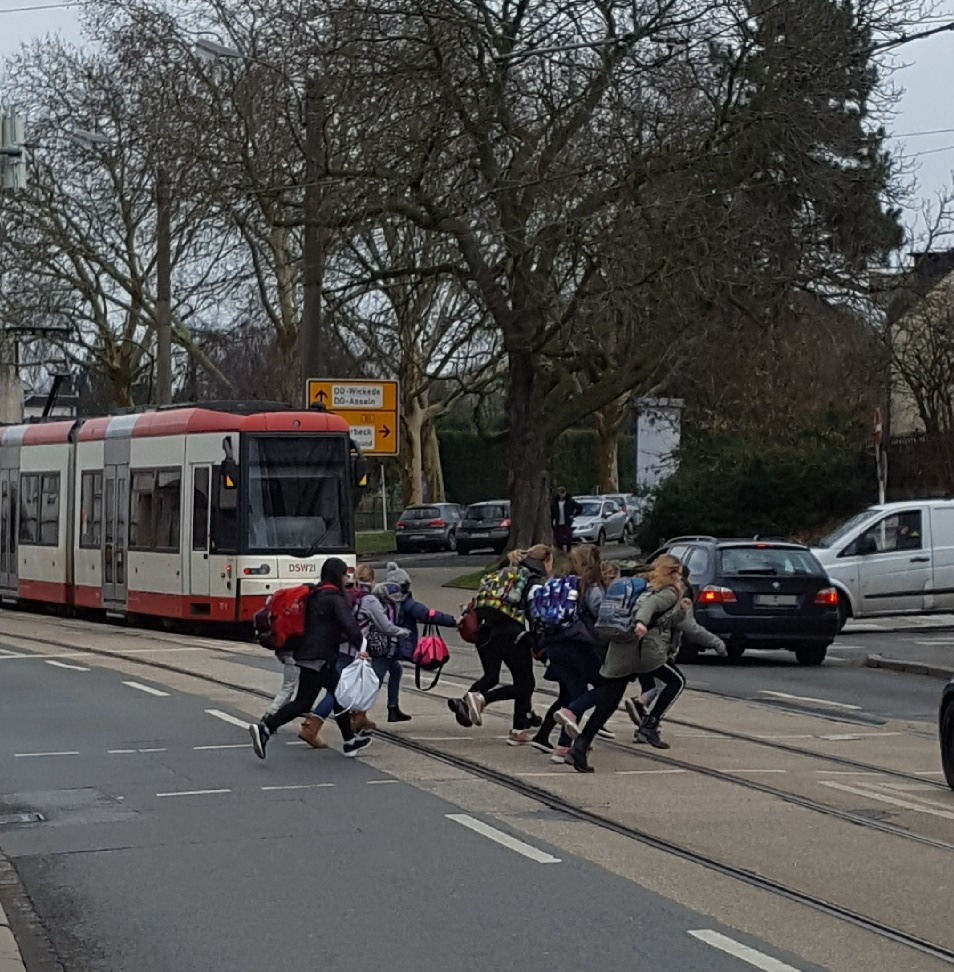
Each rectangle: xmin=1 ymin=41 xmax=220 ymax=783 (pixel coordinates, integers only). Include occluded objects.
xmin=438 ymin=429 xmax=636 ymax=504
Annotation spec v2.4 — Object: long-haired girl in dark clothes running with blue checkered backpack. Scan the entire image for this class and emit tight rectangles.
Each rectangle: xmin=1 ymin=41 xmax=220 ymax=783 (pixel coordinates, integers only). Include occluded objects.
xmin=531 ymin=543 xmax=606 ymax=763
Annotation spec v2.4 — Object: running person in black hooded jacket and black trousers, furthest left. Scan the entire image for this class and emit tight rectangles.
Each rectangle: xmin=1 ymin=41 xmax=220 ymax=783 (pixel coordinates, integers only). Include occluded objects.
xmin=248 ymin=557 xmax=371 ymax=759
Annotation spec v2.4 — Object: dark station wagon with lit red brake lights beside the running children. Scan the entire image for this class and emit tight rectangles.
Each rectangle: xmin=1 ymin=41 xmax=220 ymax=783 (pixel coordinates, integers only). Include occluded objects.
xmin=653 ymin=537 xmax=838 ymax=665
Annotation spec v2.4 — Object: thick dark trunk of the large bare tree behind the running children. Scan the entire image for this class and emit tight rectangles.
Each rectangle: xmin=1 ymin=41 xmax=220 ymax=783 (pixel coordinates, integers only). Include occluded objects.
xmin=508 ymin=351 xmax=553 ymax=550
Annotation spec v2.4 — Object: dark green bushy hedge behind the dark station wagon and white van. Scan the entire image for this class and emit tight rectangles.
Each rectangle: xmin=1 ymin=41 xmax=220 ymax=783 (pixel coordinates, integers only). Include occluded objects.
xmin=638 ymin=430 xmax=877 ymax=551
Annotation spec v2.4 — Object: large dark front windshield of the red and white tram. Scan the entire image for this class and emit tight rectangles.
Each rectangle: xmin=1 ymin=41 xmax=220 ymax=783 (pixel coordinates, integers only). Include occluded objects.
xmin=246 ymin=435 xmax=352 ymax=556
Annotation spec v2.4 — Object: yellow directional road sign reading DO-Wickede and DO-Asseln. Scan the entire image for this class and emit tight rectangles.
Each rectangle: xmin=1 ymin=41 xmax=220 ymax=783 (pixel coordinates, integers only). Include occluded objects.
xmin=308 ymin=378 xmax=400 ymax=456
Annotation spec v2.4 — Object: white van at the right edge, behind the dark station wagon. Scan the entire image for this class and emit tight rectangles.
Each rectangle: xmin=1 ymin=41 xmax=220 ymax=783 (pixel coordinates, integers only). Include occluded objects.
xmin=812 ymin=500 xmax=954 ymax=619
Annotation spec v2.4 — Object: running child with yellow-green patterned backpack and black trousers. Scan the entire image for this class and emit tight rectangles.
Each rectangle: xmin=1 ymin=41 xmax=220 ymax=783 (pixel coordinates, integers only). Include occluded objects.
xmin=447 ymin=544 xmax=553 ymax=746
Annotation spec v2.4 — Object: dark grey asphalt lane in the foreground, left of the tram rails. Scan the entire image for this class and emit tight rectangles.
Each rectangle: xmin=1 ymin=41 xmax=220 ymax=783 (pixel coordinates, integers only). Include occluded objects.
xmin=0 ymin=652 xmax=824 ymax=972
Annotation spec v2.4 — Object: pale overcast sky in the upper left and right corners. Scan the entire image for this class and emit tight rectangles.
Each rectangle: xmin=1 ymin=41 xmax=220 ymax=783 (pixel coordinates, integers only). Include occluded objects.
xmin=0 ymin=0 xmax=954 ymax=245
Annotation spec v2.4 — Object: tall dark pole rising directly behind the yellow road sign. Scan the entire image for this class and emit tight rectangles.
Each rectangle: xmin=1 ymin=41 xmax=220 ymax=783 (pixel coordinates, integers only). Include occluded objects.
xmin=298 ymin=76 xmax=327 ymax=408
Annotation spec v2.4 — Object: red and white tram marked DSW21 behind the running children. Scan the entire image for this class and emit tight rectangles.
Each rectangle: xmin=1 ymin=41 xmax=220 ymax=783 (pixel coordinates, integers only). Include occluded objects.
xmin=0 ymin=403 xmax=362 ymax=622
